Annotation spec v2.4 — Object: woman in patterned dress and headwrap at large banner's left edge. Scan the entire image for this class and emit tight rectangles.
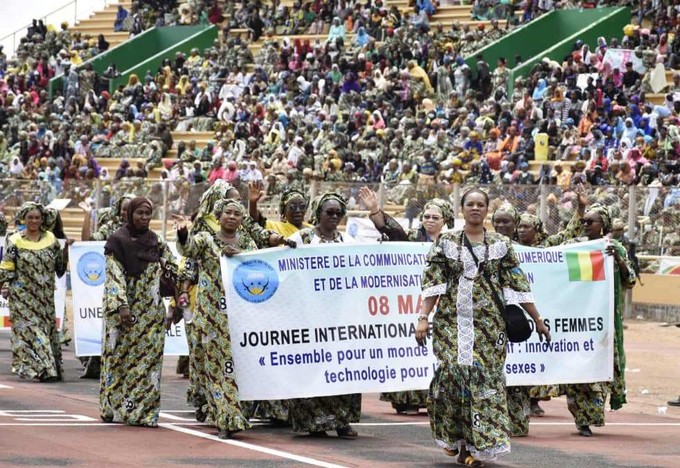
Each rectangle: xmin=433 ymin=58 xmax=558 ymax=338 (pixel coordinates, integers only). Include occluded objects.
xmin=175 ymin=199 xmax=257 ymax=439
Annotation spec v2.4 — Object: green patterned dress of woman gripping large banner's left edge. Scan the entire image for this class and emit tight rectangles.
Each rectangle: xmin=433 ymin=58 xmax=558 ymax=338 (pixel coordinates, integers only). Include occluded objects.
xmin=177 ymin=231 xmax=257 ymax=431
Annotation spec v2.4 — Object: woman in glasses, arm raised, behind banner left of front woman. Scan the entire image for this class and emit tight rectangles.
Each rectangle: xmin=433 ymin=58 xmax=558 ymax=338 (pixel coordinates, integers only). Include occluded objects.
xmin=359 ymin=187 xmax=455 ymax=414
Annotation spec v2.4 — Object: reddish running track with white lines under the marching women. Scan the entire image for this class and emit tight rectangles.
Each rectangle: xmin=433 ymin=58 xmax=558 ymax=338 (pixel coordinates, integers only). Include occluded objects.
xmin=0 ymin=322 xmax=680 ymax=468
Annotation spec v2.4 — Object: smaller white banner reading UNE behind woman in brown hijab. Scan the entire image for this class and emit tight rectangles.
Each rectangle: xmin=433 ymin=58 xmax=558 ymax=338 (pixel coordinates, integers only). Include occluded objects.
xmin=69 ymin=242 xmax=189 ymax=356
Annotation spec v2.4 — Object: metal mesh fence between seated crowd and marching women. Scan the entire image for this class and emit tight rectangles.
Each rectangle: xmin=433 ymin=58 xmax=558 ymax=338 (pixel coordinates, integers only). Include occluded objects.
xmin=0 ymin=178 xmax=680 ymax=250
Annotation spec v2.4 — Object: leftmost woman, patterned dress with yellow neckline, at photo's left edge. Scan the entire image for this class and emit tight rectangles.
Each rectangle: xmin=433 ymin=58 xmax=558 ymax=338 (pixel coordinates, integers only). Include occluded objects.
xmin=0 ymin=202 xmax=68 ymax=382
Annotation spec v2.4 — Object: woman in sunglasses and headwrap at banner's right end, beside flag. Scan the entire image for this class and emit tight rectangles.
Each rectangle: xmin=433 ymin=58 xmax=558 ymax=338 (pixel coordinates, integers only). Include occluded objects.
xmin=565 ymin=203 xmax=636 ymax=437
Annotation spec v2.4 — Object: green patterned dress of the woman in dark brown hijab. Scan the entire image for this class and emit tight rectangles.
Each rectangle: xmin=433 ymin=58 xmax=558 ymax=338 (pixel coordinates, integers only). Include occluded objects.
xmin=99 ymin=236 xmax=176 ymax=427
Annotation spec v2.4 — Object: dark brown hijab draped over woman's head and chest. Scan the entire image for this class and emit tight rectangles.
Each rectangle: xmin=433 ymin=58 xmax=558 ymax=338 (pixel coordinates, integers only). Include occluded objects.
xmin=104 ymin=197 xmax=160 ymax=276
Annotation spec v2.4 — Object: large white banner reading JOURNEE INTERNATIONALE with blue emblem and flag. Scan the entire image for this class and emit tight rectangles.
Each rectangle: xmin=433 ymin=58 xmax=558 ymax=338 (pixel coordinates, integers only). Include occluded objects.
xmin=222 ymin=241 xmax=614 ymax=400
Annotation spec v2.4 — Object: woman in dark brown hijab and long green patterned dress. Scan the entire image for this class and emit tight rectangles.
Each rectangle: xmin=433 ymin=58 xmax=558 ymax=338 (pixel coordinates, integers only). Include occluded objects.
xmin=99 ymin=197 xmax=177 ymax=427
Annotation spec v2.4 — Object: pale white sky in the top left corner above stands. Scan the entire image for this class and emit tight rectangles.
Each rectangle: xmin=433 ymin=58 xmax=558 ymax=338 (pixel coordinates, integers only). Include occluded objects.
xmin=0 ymin=0 xmax=118 ymax=57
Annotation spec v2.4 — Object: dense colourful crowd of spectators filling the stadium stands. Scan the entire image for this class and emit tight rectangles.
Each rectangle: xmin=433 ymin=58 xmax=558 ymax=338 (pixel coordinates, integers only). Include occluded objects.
xmin=0 ymin=0 xmax=680 ymax=253
